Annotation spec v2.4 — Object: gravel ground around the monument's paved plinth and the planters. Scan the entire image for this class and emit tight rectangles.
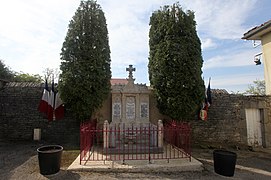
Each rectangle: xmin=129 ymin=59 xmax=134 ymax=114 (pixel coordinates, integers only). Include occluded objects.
xmin=0 ymin=142 xmax=271 ymax=180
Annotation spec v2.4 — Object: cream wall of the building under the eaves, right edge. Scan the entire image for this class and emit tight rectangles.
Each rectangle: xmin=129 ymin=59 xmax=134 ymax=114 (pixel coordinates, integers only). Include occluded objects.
xmin=262 ymin=33 xmax=271 ymax=95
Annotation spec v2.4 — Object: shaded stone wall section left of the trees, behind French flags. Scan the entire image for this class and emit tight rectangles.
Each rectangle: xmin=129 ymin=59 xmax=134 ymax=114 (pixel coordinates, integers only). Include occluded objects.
xmin=0 ymin=83 xmax=79 ymax=144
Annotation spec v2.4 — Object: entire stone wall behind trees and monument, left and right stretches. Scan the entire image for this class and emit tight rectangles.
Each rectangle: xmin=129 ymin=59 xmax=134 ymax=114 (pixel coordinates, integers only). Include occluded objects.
xmin=0 ymin=84 xmax=271 ymax=147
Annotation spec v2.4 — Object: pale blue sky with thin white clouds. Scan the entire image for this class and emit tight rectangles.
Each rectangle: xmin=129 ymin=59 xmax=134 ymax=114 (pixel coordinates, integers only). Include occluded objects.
xmin=0 ymin=0 xmax=271 ymax=93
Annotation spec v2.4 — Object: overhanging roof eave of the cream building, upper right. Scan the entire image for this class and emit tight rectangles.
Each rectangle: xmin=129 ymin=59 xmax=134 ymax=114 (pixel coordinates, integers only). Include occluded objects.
xmin=242 ymin=20 xmax=271 ymax=40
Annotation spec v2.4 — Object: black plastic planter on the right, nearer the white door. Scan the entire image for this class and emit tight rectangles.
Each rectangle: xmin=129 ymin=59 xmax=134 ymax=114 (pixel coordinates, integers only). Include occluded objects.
xmin=213 ymin=150 xmax=237 ymax=176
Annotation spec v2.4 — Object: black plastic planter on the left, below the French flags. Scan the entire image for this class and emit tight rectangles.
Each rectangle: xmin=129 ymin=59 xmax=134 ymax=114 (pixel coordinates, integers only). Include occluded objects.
xmin=37 ymin=145 xmax=63 ymax=175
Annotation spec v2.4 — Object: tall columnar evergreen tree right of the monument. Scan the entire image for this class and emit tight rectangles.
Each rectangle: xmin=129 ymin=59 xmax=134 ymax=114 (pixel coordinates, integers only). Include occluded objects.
xmin=148 ymin=3 xmax=205 ymax=120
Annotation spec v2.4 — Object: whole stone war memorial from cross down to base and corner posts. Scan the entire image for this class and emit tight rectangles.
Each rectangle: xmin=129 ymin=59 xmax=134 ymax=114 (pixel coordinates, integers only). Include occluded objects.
xmin=104 ymin=65 xmax=163 ymax=153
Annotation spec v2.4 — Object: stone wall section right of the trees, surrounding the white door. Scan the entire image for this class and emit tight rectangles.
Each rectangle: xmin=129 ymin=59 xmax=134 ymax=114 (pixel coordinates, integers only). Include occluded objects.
xmin=191 ymin=90 xmax=271 ymax=147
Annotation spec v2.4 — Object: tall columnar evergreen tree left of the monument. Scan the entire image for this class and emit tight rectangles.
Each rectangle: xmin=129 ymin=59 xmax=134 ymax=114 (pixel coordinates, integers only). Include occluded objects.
xmin=59 ymin=0 xmax=111 ymax=121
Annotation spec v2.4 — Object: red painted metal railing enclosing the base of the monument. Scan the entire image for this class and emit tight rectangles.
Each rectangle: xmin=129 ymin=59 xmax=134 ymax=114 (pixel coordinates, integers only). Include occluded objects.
xmin=80 ymin=122 xmax=191 ymax=164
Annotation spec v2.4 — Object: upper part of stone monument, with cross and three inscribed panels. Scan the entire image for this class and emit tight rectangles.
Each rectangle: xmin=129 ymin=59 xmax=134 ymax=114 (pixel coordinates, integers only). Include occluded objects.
xmin=112 ymin=65 xmax=150 ymax=126
